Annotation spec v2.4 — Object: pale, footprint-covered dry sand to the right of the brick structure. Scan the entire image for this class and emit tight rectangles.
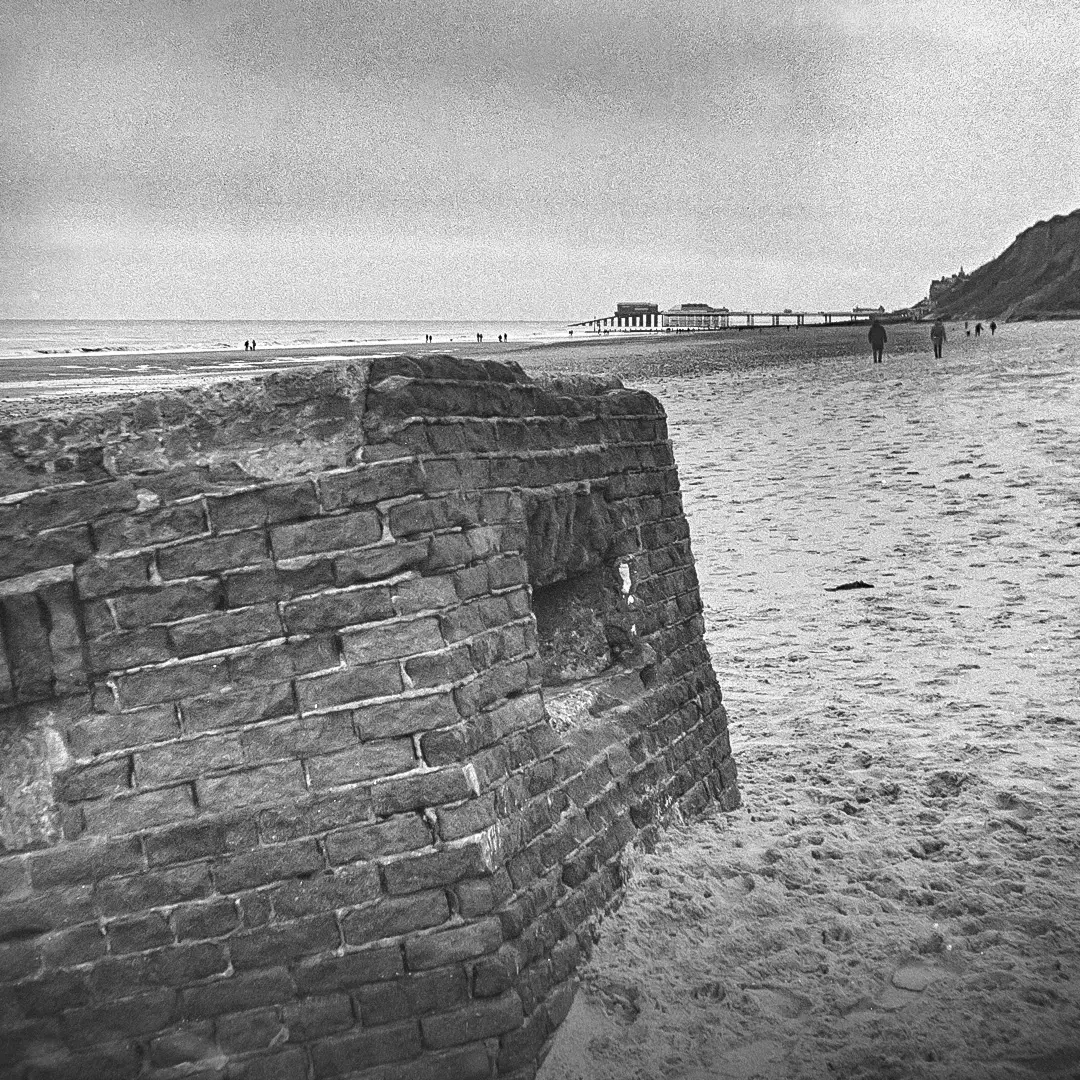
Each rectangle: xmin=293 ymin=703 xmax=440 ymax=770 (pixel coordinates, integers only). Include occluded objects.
xmin=540 ymin=324 xmax=1080 ymax=1080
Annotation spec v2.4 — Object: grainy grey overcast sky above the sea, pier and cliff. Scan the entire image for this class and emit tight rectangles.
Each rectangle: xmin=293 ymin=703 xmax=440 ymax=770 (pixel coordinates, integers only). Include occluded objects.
xmin=0 ymin=0 xmax=1080 ymax=320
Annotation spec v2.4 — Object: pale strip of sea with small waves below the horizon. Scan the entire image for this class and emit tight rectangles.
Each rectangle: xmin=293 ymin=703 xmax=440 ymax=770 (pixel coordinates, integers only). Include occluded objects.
xmin=0 ymin=319 xmax=566 ymax=362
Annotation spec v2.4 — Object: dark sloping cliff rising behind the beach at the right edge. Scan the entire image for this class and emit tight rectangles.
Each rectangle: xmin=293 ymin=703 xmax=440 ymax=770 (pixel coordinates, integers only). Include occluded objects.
xmin=939 ymin=210 xmax=1080 ymax=322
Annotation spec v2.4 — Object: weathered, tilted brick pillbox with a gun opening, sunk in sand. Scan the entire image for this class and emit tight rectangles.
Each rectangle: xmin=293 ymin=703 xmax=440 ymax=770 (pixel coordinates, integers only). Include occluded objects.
xmin=0 ymin=356 xmax=738 ymax=1080
